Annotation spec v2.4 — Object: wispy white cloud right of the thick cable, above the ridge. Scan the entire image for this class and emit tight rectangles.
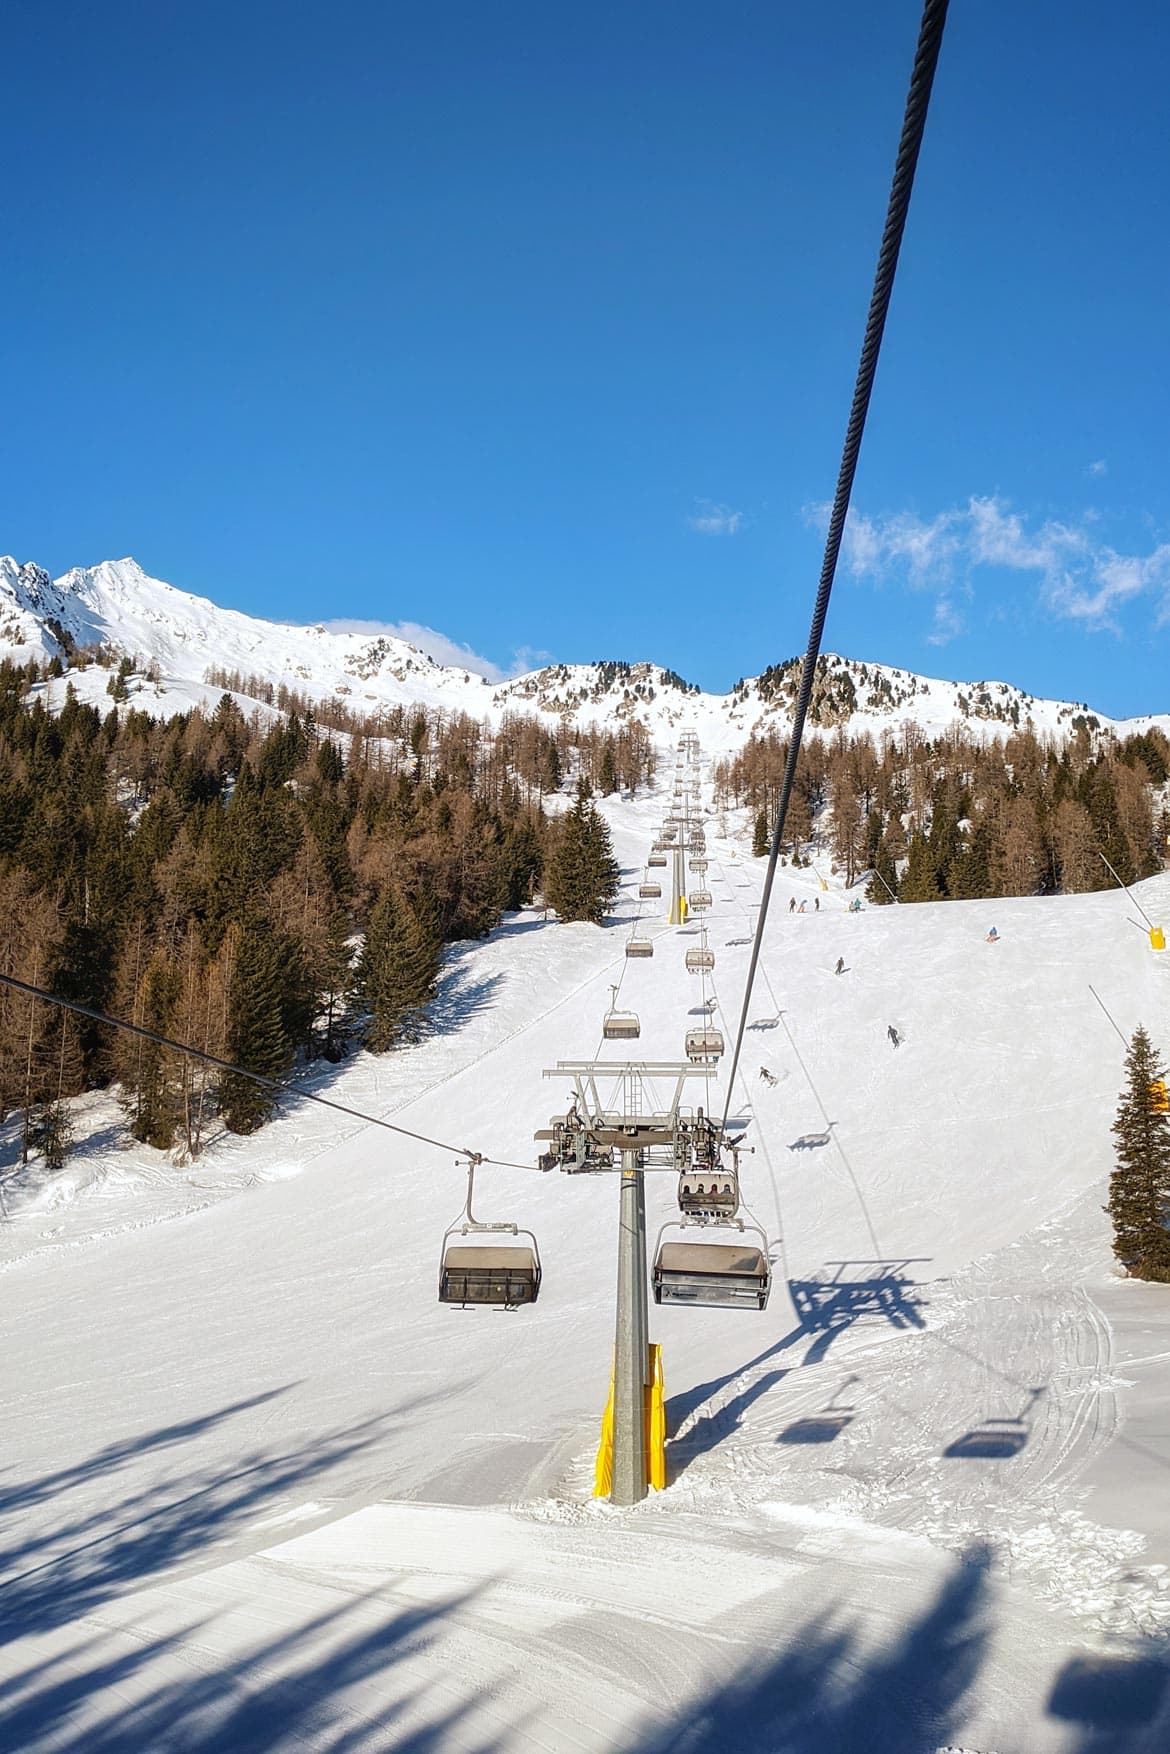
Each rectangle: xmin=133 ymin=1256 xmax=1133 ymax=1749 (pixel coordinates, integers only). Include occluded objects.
xmin=827 ymin=496 xmax=1170 ymax=644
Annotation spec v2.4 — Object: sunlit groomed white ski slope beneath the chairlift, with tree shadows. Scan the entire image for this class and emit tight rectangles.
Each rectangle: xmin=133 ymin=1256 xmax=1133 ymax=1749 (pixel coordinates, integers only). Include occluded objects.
xmin=0 ymin=793 xmax=1170 ymax=1754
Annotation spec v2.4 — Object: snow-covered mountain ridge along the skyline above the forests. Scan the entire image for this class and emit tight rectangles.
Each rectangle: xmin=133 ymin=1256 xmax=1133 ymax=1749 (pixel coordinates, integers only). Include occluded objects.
xmin=0 ymin=558 xmax=1170 ymax=752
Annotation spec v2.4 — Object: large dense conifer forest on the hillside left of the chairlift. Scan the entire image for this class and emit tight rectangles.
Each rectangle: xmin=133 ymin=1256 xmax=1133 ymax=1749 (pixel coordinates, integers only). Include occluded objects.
xmin=0 ymin=665 xmax=654 ymax=1161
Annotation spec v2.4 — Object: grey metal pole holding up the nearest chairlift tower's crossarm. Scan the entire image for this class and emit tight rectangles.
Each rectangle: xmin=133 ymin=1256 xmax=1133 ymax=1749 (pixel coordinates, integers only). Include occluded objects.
xmin=609 ymin=1151 xmax=649 ymax=1505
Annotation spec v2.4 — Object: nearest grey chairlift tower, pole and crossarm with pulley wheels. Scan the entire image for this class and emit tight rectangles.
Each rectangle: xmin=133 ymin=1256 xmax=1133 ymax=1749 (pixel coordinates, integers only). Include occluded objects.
xmin=537 ymin=1059 xmax=723 ymax=1505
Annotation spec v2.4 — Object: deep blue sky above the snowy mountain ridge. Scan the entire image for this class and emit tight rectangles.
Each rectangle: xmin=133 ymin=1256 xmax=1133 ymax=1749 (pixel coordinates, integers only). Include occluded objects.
xmin=0 ymin=0 xmax=1170 ymax=714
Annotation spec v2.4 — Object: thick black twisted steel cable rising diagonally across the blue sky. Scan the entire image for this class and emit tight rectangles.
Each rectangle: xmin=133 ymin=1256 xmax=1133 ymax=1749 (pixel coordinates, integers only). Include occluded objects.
xmin=723 ymin=0 xmax=947 ymax=1124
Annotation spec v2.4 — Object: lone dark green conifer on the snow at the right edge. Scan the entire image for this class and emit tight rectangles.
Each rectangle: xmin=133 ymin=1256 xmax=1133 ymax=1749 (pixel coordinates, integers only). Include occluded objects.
xmin=1105 ymin=1026 xmax=1170 ymax=1284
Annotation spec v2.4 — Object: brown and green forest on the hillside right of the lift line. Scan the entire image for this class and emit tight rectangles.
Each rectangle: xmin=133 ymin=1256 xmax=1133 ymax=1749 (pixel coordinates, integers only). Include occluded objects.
xmin=716 ymin=724 xmax=1170 ymax=905
